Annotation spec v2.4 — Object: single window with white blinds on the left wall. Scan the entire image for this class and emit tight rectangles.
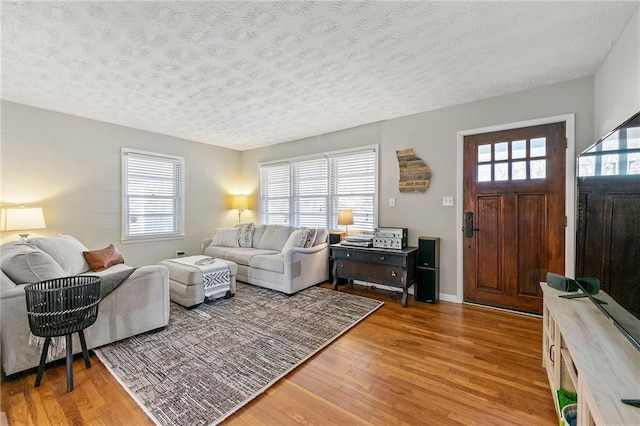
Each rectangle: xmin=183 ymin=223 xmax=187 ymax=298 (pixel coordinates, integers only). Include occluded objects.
xmin=122 ymin=148 xmax=184 ymax=241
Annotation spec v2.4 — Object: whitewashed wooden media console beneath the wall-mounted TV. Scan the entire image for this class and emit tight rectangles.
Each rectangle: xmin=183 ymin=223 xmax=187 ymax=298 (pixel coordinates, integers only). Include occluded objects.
xmin=541 ymin=283 xmax=640 ymax=425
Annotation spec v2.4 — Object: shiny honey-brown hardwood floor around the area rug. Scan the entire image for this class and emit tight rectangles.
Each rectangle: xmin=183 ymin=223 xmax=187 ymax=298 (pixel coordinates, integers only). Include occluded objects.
xmin=1 ymin=285 xmax=558 ymax=426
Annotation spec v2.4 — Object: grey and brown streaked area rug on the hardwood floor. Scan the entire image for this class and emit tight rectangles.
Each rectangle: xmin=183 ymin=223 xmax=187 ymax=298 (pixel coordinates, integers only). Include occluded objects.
xmin=95 ymin=283 xmax=382 ymax=425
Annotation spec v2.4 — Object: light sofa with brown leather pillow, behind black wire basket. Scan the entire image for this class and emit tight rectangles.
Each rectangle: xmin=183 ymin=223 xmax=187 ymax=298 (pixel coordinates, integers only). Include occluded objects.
xmin=0 ymin=235 xmax=169 ymax=375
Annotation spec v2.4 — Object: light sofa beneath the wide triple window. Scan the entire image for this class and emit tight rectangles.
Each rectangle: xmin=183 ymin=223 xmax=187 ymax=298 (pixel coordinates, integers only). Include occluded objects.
xmin=202 ymin=223 xmax=329 ymax=294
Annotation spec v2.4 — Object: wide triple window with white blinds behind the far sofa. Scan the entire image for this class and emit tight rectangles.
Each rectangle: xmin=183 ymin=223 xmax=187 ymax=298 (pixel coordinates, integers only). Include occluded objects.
xmin=259 ymin=147 xmax=378 ymax=233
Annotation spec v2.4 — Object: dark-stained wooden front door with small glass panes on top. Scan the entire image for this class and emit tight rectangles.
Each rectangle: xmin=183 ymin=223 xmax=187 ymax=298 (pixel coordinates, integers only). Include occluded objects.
xmin=463 ymin=123 xmax=566 ymax=313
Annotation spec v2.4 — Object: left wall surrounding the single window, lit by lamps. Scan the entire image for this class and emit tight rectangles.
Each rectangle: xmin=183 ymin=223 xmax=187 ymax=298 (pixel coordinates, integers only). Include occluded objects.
xmin=0 ymin=102 xmax=244 ymax=265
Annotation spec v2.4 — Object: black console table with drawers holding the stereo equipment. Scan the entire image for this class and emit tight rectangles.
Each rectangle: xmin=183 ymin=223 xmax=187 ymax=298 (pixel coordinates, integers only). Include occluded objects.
xmin=329 ymin=244 xmax=418 ymax=308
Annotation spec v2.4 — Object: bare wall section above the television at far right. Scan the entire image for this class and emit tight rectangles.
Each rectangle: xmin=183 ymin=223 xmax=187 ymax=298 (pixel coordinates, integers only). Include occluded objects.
xmin=594 ymin=7 xmax=640 ymax=142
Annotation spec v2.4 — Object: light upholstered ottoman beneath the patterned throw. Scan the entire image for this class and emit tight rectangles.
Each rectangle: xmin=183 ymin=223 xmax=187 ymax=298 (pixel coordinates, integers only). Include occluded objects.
xmin=160 ymin=256 xmax=238 ymax=308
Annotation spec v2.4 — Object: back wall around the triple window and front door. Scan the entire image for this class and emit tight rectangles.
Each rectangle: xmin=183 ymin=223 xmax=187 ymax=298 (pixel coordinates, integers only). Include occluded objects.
xmin=242 ymin=77 xmax=594 ymax=298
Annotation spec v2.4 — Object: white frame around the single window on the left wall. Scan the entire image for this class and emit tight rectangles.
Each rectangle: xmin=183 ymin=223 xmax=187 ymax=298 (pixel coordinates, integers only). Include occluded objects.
xmin=120 ymin=148 xmax=185 ymax=244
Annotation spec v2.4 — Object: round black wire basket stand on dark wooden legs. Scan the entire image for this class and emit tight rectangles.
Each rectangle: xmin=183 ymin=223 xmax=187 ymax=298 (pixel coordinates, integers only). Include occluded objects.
xmin=24 ymin=275 xmax=100 ymax=392
